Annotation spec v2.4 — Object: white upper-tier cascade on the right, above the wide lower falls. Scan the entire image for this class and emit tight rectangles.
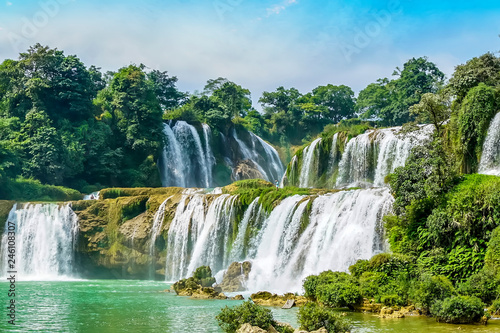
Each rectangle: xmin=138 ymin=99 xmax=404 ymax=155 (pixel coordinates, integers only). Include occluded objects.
xmin=288 ymin=125 xmax=433 ymax=188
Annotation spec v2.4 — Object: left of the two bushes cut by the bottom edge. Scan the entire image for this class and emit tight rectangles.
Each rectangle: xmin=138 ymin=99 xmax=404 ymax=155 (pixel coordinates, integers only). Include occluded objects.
xmin=215 ymin=301 xmax=275 ymax=333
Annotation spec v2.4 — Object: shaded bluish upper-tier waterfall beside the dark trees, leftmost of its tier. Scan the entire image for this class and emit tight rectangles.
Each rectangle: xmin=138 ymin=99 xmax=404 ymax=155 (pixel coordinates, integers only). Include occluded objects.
xmin=159 ymin=121 xmax=213 ymax=187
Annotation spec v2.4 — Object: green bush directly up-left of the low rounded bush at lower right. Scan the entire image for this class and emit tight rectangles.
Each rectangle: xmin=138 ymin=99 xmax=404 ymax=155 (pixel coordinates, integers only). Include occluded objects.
xmin=412 ymin=274 xmax=457 ymax=311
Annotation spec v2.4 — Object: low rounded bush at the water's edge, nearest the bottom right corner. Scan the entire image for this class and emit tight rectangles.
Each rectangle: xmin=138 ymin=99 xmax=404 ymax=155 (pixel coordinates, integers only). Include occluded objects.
xmin=431 ymin=296 xmax=484 ymax=324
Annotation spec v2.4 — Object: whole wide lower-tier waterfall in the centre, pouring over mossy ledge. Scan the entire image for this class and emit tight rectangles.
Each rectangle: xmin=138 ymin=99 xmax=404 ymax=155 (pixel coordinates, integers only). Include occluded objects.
xmin=162 ymin=188 xmax=393 ymax=291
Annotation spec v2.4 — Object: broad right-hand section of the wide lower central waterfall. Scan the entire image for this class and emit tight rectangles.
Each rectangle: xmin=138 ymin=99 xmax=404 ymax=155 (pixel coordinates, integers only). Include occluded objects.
xmin=247 ymin=189 xmax=392 ymax=292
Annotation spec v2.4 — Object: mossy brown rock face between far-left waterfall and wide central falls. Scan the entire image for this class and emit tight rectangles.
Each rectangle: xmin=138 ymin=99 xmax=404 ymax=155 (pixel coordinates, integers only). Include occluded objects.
xmin=71 ymin=188 xmax=184 ymax=279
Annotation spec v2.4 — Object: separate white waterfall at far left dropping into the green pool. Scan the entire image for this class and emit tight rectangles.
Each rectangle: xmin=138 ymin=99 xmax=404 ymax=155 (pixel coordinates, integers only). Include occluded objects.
xmin=0 ymin=204 xmax=78 ymax=281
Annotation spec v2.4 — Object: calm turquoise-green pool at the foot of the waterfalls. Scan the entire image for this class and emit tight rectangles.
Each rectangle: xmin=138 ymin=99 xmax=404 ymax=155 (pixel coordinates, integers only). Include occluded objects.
xmin=0 ymin=280 xmax=500 ymax=333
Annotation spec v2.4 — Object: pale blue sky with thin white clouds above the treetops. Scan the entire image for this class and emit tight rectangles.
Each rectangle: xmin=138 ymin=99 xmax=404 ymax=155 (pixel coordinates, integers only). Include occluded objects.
xmin=0 ymin=0 xmax=500 ymax=109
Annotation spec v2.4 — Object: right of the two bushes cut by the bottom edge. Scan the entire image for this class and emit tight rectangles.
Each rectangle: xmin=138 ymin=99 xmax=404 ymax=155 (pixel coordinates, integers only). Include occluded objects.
xmin=298 ymin=303 xmax=352 ymax=333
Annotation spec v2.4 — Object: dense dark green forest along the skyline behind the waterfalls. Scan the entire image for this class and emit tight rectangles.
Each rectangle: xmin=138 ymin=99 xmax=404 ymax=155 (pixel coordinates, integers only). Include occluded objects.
xmin=0 ymin=44 xmax=468 ymax=198
